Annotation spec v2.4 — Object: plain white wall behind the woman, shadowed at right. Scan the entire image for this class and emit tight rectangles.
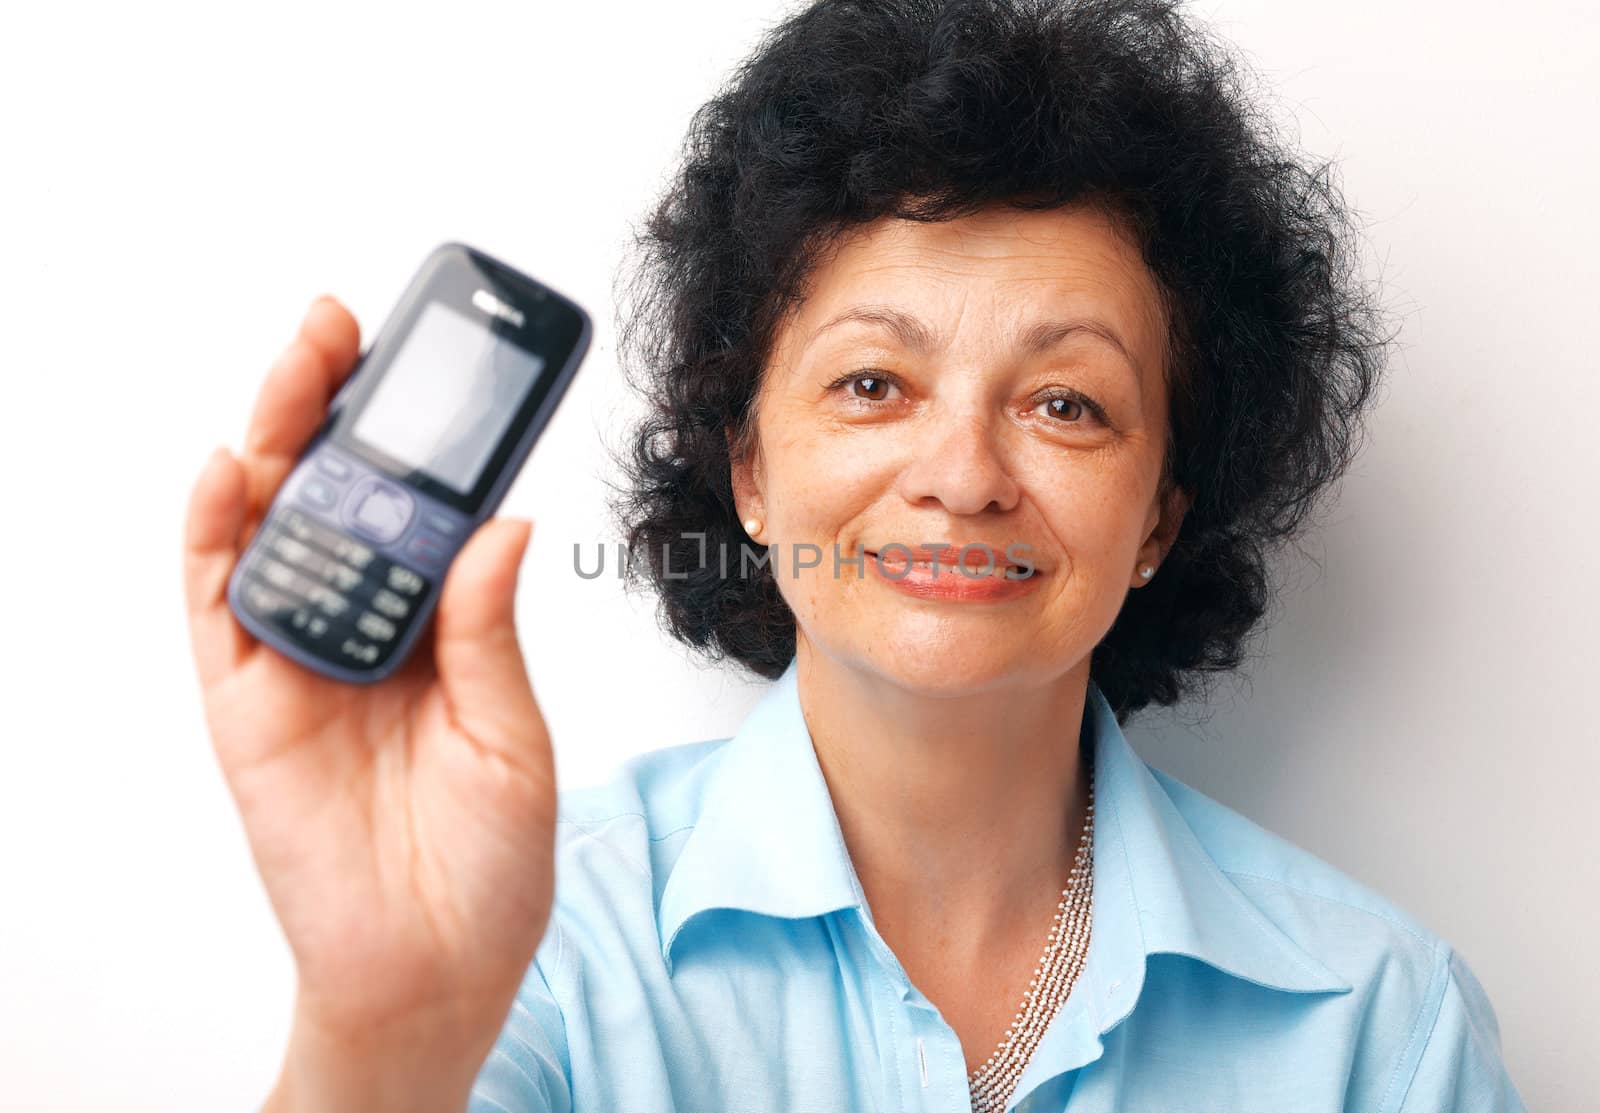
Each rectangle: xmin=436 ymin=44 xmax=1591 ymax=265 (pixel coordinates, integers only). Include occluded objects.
xmin=0 ymin=0 xmax=1600 ymax=1113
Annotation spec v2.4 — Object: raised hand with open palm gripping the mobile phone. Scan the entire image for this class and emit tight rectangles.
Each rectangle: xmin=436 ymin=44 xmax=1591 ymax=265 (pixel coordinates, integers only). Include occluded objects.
xmin=184 ymin=297 xmax=557 ymax=1106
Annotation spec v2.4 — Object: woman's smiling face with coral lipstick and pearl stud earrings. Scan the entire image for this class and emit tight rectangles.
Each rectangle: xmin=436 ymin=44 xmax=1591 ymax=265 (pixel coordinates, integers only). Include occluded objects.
xmin=734 ymin=195 xmax=1187 ymax=694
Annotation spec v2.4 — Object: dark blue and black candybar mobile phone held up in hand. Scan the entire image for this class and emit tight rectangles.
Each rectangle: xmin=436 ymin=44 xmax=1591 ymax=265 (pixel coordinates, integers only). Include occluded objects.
xmin=227 ymin=243 xmax=594 ymax=683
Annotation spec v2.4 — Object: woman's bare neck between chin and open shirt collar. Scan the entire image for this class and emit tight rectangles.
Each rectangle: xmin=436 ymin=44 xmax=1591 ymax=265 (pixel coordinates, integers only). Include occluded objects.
xmin=797 ymin=638 xmax=1088 ymax=971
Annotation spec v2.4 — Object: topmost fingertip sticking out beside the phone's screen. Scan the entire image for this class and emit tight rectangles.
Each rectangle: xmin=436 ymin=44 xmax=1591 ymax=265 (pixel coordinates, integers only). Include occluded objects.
xmin=245 ymin=294 xmax=362 ymax=461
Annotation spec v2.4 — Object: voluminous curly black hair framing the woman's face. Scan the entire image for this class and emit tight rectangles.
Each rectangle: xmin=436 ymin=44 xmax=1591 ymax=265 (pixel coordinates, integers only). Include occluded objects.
xmin=611 ymin=0 xmax=1392 ymax=721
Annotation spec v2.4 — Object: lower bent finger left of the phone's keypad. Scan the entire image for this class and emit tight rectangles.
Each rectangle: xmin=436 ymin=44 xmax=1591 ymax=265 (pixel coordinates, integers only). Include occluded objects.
xmin=184 ymin=448 xmax=256 ymax=688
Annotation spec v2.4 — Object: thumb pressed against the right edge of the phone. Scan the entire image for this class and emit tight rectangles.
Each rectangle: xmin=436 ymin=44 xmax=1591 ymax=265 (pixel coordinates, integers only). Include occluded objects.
xmin=434 ymin=518 xmax=542 ymax=756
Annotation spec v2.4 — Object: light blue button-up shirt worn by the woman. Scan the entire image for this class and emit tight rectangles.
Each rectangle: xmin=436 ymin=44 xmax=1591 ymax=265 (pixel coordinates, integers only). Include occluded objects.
xmin=469 ymin=662 xmax=1525 ymax=1113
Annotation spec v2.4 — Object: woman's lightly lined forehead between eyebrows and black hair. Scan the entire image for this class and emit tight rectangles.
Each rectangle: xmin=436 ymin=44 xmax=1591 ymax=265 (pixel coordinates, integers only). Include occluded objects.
xmin=794 ymin=205 xmax=1165 ymax=356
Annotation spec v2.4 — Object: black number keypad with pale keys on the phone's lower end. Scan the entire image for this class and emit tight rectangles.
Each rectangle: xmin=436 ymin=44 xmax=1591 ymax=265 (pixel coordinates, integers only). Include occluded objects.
xmin=242 ymin=510 xmax=430 ymax=667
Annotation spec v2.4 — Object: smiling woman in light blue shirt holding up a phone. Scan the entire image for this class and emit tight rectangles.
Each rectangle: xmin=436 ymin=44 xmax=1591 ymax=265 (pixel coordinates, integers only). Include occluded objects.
xmin=186 ymin=0 xmax=1522 ymax=1113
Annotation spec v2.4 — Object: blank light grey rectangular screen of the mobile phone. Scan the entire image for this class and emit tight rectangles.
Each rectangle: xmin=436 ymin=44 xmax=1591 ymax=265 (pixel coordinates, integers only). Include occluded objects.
xmin=350 ymin=301 xmax=546 ymax=496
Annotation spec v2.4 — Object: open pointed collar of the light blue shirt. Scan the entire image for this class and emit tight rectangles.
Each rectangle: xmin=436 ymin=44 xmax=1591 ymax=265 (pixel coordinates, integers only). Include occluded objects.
xmin=659 ymin=660 xmax=1352 ymax=1068
